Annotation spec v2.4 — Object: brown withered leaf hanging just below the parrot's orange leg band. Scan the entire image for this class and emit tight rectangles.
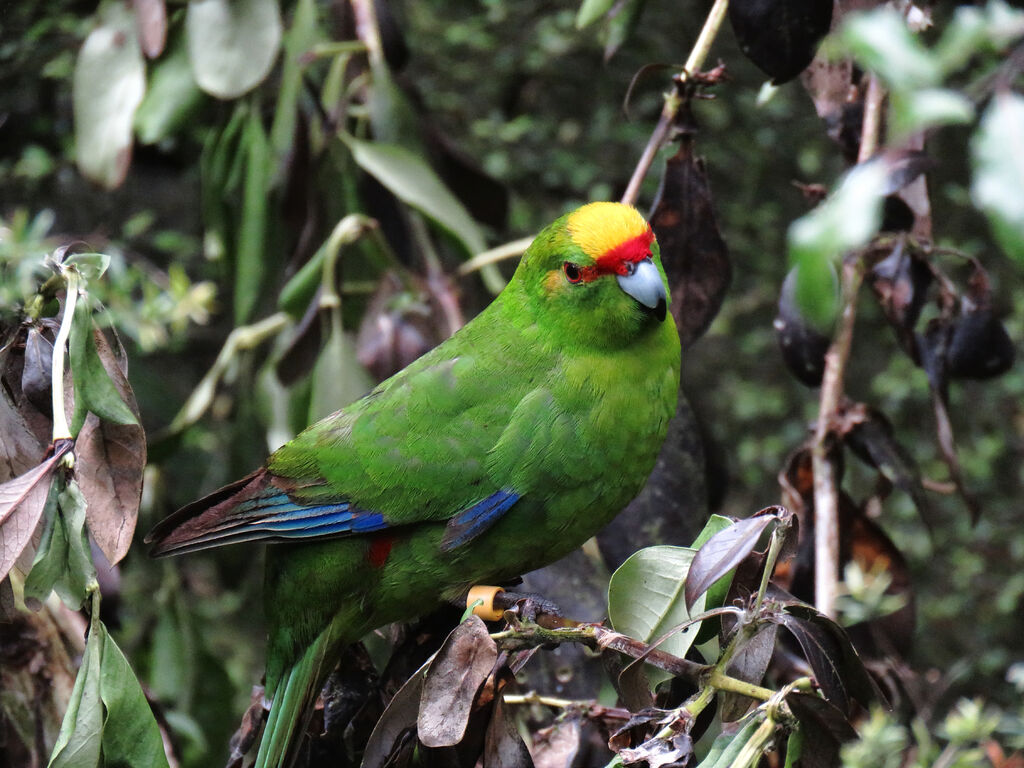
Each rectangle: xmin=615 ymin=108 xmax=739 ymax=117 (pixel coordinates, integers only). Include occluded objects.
xmin=417 ymin=616 xmax=498 ymax=746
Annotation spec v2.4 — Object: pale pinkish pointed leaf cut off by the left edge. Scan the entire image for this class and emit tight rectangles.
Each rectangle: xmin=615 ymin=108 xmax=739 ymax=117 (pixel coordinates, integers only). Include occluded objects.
xmin=0 ymin=440 xmax=74 ymax=579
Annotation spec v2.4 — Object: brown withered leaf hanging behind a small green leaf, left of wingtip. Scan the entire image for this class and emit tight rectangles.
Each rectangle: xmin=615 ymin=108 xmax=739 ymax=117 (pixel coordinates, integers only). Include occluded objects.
xmin=75 ymin=325 xmax=145 ymax=565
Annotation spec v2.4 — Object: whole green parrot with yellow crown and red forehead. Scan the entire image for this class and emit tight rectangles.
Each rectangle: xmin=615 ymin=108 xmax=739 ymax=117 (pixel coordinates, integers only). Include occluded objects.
xmin=146 ymin=203 xmax=680 ymax=768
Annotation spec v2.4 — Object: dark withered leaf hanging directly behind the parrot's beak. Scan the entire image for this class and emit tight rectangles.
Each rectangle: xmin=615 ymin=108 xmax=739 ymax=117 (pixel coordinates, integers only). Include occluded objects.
xmin=649 ymin=139 xmax=732 ymax=346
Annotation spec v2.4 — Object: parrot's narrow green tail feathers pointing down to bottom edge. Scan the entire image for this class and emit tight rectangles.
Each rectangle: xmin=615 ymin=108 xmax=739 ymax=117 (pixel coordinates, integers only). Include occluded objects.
xmin=255 ymin=623 xmax=337 ymax=768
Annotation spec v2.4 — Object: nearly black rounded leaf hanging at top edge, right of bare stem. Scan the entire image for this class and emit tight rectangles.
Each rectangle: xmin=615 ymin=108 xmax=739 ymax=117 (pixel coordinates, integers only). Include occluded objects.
xmin=729 ymin=0 xmax=833 ymax=84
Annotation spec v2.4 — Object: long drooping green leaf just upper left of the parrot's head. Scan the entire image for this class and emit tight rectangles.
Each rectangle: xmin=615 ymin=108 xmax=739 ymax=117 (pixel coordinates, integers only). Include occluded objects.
xmin=348 ymin=138 xmax=485 ymax=256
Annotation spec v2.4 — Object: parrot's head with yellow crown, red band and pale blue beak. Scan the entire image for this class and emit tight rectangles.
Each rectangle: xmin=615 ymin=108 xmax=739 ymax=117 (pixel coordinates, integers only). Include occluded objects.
xmin=509 ymin=203 xmax=669 ymax=348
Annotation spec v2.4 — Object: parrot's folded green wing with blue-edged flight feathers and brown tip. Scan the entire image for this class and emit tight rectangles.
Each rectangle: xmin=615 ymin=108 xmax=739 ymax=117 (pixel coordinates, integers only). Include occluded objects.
xmin=146 ymin=348 xmax=561 ymax=555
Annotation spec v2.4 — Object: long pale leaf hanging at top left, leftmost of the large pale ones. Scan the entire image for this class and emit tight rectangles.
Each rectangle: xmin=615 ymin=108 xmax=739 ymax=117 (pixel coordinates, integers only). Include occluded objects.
xmin=72 ymin=2 xmax=145 ymax=189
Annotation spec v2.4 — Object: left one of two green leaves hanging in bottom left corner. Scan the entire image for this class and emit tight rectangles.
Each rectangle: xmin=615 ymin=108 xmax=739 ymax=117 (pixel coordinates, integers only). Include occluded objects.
xmin=49 ymin=615 xmax=105 ymax=768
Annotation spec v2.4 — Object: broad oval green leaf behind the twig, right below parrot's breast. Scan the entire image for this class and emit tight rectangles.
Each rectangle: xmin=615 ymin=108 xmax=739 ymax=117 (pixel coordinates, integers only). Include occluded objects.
xmin=608 ymin=546 xmax=705 ymax=685
